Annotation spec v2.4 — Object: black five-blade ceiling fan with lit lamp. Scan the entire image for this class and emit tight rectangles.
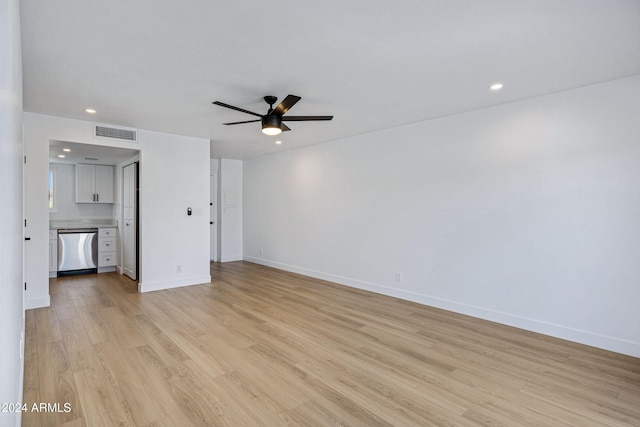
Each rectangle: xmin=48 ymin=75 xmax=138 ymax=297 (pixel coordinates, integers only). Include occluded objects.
xmin=213 ymin=95 xmax=333 ymax=135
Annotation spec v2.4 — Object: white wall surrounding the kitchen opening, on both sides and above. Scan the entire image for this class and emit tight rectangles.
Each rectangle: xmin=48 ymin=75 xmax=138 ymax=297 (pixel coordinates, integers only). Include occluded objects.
xmin=24 ymin=113 xmax=211 ymax=302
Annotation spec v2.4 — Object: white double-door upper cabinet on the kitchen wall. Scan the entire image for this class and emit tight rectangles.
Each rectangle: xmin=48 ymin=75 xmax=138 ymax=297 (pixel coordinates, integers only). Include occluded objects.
xmin=76 ymin=163 xmax=114 ymax=203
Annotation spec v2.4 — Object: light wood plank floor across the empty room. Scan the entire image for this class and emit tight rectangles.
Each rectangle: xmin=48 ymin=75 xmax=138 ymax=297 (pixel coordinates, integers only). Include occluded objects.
xmin=23 ymin=262 xmax=640 ymax=427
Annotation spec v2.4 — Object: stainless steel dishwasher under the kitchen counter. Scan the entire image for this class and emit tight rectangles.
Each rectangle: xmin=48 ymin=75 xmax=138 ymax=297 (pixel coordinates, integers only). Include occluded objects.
xmin=58 ymin=228 xmax=98 ymax=276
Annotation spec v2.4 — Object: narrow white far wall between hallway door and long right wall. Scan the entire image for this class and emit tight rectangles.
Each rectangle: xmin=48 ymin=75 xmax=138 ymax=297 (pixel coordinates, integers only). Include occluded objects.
xmin=218 ymin=159 xmax=243 ymax=262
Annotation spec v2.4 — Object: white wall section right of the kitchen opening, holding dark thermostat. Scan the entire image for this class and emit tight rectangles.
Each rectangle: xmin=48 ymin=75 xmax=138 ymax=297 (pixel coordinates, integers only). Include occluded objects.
xmin=139 ymin=131 xmax=211 ymax=292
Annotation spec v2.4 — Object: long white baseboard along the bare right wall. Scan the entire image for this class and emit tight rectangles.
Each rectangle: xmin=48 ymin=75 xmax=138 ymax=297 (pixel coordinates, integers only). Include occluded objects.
xmin=244 ymin=256 xmax=640 ymax=357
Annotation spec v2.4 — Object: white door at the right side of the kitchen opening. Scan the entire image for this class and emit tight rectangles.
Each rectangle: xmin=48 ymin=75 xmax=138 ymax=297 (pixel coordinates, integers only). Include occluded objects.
xmin=122 ymin=163 xmax=138 ymax=280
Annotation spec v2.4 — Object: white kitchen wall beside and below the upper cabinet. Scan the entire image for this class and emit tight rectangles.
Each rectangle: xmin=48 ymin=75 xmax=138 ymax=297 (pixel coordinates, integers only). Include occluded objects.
xmin=49 ymin=163 xmax=115 ymax=221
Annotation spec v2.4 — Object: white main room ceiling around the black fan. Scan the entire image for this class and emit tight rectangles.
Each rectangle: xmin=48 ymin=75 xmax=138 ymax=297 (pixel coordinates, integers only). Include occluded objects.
xmin=21 ymin=0 xmax=640 ymax=159
